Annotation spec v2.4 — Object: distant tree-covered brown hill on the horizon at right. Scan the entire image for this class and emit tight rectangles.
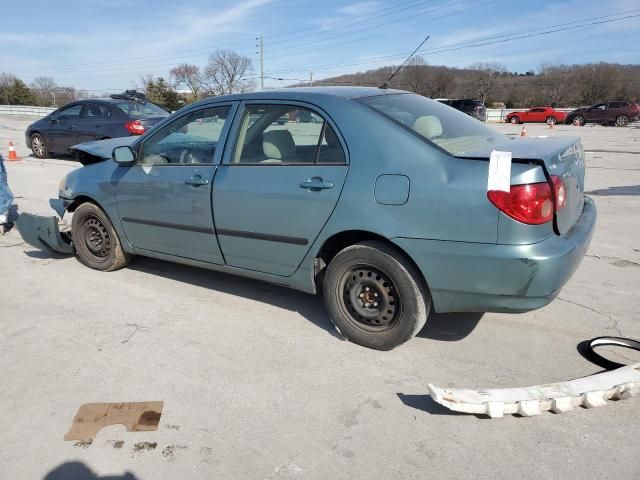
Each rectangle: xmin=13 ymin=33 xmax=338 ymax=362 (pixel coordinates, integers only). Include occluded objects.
xmin=298 ymin=57 xmax=640 ymax=108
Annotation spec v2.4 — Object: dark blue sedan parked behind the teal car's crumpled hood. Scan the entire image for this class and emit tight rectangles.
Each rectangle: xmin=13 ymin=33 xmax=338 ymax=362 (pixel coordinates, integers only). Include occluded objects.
xmin=25 ymin=90 xmax=169 ymax=158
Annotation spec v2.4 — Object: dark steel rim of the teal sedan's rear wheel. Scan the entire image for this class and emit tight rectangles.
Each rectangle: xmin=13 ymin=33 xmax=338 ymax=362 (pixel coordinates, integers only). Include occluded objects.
xmin=338 ymin=264 xmax=402 ymax=333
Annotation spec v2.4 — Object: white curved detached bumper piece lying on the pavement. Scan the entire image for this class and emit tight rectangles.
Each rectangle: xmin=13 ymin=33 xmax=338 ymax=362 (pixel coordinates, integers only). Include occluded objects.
xmin=429 ymin=363 xmax=640 ymax=418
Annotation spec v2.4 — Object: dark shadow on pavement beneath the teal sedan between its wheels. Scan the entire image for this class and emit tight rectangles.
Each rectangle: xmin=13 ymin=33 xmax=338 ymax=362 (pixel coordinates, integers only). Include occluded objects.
xmin=127 ymin=256 xmax=341 ymax=338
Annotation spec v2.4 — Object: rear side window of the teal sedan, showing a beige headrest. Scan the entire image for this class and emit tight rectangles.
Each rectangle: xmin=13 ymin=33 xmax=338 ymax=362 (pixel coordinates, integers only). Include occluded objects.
xmin=231 ymin=105 xmax=345 ymax=165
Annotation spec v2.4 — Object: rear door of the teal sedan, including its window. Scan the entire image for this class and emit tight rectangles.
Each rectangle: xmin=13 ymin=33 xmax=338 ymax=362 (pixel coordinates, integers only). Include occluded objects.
xmin=213 ymin=102 xmax=348 ymax=276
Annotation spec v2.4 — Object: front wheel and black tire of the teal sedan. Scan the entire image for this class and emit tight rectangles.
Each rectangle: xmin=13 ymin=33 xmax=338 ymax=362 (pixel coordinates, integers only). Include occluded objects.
xmin=71 ymin=203 xmax=132 ymax=272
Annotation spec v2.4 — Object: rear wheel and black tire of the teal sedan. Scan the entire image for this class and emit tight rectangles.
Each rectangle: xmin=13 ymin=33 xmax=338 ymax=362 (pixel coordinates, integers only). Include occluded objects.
xmin=323 ymin=241 xmax=431 ymax=350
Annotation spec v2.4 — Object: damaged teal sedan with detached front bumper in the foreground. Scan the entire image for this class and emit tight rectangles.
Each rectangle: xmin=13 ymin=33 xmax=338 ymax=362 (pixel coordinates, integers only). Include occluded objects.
xmin=19 ymin=87 xmax=596 ymax=350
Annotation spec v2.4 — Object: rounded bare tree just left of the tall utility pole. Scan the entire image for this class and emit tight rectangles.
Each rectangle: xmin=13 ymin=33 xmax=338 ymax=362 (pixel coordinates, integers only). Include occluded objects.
xmin=204 ymin=50 xmax=256 ymax=95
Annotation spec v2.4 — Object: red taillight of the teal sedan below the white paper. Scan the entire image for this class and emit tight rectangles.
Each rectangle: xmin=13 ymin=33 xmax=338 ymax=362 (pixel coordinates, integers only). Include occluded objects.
xmin=487 ymin=176 xmax=567 ymax=225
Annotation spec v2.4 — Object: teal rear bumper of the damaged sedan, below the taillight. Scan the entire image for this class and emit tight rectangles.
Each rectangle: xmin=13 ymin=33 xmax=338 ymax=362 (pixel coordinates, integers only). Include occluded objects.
xmin=394 ymin=196 xmax=597 ymax=313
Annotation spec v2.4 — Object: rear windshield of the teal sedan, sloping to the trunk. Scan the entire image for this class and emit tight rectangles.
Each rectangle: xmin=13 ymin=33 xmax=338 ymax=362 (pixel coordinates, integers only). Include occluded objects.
xmin=358 ymin=93 xmax=509 ymax=155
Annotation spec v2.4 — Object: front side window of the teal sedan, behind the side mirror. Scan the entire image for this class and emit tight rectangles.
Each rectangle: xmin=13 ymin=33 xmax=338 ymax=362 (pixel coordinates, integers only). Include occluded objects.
xmin=139 ymin=106 xmax=230 ymax=165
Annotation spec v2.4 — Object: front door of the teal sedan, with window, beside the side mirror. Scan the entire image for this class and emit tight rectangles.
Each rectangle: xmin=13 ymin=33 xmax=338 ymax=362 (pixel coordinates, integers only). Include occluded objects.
xmin=115 ymin=103 xmax=236 ymax=264
